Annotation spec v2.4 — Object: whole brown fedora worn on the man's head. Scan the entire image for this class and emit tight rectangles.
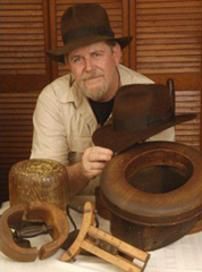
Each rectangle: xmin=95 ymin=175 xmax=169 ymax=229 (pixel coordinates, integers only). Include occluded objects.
xmin=48 ymin=3 xmax=132 ymax=63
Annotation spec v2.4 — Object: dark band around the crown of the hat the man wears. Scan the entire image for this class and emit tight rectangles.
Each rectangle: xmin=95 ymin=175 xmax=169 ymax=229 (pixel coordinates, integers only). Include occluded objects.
xmin=62 ymin=26 xmax=114 ymax=44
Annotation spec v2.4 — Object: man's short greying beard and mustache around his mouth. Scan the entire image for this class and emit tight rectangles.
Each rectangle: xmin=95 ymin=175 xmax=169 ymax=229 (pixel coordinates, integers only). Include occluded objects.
xmin=76 ymin=70 xmax=108 ymax=101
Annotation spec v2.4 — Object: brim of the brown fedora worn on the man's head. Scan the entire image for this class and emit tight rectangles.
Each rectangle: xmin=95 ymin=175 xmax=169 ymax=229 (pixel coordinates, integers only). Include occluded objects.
xmin=47 ymin=36 xmax=132 ymax=63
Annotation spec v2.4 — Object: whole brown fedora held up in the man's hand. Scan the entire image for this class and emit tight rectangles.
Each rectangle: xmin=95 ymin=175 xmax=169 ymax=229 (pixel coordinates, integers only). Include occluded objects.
xmin=93 ymin=84 xmax=196 ymax=153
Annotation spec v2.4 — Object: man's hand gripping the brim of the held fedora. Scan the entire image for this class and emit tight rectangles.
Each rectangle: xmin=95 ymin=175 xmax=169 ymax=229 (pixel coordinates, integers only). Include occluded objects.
xmin=81 ymin=146 xmax=113 ymax=179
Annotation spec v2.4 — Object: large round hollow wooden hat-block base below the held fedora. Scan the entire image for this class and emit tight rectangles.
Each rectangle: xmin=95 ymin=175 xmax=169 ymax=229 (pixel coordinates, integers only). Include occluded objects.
xmin=99 ymin=142 xmax=202 ymax=251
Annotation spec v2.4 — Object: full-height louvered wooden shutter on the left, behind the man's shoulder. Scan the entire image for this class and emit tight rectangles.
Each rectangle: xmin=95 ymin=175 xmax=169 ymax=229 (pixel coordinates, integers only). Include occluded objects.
xmin=0 ymin=0 xmax=50 ymax=201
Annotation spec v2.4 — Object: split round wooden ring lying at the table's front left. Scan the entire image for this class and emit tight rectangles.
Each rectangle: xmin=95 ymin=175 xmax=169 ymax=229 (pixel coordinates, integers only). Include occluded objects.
xmin=0 ymin=202 xmax=69 ymax=262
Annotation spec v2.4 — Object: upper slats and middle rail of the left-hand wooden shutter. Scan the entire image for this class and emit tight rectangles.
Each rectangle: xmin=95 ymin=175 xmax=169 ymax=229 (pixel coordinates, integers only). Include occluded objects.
xmin=0 ymin=0 xmax=49 ymax=92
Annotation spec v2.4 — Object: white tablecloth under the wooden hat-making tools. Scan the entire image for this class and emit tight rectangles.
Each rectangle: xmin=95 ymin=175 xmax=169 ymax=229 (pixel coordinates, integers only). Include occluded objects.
xmin=0 ymin=203 xmax=202 ymax=272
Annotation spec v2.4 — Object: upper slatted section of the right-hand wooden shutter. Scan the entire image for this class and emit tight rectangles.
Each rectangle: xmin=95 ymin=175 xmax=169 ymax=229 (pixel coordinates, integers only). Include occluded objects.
xmin=133 ymin=0 xmax=202 ymax=74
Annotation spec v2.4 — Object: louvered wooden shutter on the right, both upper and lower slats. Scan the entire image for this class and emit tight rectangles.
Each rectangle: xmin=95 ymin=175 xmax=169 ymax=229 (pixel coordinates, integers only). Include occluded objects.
xmin=130 ymin=0 xmax=202 ymax=149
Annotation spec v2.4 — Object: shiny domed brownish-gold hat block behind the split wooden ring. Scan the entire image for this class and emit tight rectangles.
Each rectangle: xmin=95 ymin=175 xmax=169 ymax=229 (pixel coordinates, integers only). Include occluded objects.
xmin=9 ymin=159 xmax=69 ymax=210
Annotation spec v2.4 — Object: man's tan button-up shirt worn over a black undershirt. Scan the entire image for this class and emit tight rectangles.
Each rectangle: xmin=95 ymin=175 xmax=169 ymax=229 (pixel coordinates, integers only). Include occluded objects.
xmin=31 ymin=65 xmax=174 ymax=164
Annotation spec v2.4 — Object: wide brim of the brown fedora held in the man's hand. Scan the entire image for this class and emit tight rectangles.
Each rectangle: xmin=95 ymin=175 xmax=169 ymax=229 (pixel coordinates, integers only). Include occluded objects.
xmin=93 ymin=113 xmax=196 ymax=153
